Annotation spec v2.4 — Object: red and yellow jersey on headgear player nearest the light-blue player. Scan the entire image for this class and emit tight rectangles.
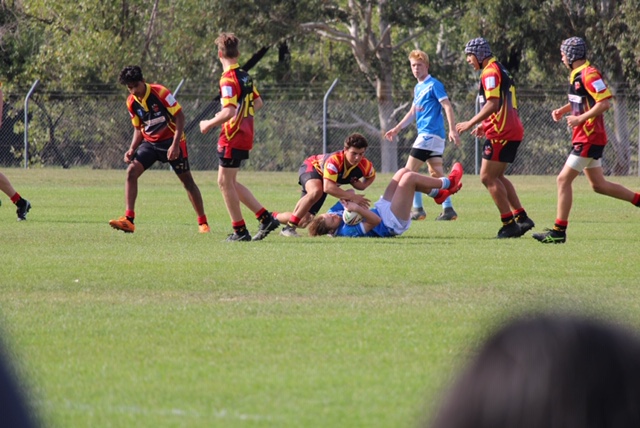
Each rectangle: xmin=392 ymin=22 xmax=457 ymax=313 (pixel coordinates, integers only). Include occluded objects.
xmin=478 ymin=58 xmax=524 ymax=141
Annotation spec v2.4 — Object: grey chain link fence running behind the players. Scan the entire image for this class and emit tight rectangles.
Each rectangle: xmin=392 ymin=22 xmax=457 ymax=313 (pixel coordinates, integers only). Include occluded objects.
xmin=0 ymin=83 xmax=640 ymax=175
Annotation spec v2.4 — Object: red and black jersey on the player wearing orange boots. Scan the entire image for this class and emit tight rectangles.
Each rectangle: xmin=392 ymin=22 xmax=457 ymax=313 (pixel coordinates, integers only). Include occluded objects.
xmin=127 ymin=83 xmax=186 ymax=143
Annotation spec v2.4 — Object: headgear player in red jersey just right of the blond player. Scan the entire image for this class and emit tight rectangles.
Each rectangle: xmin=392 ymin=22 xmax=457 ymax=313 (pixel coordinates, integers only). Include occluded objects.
xmin=456 ymin=37 xmax=534 ymax=238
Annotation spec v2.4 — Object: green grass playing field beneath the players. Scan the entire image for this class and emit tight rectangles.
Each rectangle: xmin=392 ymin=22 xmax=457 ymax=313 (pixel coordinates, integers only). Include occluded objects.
xmin=0 ymin=169 xmax=640 ymax=428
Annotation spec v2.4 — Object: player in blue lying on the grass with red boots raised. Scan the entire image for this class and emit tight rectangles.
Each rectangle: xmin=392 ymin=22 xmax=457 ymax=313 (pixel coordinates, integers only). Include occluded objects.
xmin=309 ymin=162 xmax=463 ymax=238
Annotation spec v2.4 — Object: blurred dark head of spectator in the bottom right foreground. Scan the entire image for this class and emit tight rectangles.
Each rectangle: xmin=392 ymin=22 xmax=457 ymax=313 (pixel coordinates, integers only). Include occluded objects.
xmin=432 ymin=315 xmax=640 ymax=428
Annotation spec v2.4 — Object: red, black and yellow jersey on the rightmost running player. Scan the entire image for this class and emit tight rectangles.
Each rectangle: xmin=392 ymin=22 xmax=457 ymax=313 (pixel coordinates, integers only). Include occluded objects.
xmin=569 ymin=61 xmax=612 ymax=146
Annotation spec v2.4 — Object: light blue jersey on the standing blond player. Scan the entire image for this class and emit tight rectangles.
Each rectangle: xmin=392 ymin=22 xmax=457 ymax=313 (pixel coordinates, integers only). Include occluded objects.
xmin=413 ymin=75 xmax=449 ymax=139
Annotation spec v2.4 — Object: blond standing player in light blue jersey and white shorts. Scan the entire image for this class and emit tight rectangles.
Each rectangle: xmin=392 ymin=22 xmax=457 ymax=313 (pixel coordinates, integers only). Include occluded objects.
xmin=385 ymin=50 xmax=460 ymax=220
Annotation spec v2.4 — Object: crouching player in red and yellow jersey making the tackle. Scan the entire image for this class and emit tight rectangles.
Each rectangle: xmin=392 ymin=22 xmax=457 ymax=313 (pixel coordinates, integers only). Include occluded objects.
xmin=274 ymin=133 xmax=376 ymax=237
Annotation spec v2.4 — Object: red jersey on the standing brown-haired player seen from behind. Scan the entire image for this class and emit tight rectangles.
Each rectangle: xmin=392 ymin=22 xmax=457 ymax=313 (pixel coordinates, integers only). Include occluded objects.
xmin=218 ymin=64 xmax=260 ymax=150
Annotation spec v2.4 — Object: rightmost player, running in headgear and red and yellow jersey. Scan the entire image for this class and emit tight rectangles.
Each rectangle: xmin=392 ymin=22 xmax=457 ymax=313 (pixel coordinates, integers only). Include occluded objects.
xmin=533 ymin=37 xmax=640 ymax=244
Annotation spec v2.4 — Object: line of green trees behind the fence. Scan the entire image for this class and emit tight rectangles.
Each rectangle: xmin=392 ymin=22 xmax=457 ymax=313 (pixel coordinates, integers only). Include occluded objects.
xmin=0 ymin=0 xmax=640 ymax=173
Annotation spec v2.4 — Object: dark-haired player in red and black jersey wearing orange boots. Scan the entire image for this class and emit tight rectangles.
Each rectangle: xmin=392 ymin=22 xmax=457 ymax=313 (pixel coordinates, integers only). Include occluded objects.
xmin=109 ymin=65 xmax=210 ymax=233
